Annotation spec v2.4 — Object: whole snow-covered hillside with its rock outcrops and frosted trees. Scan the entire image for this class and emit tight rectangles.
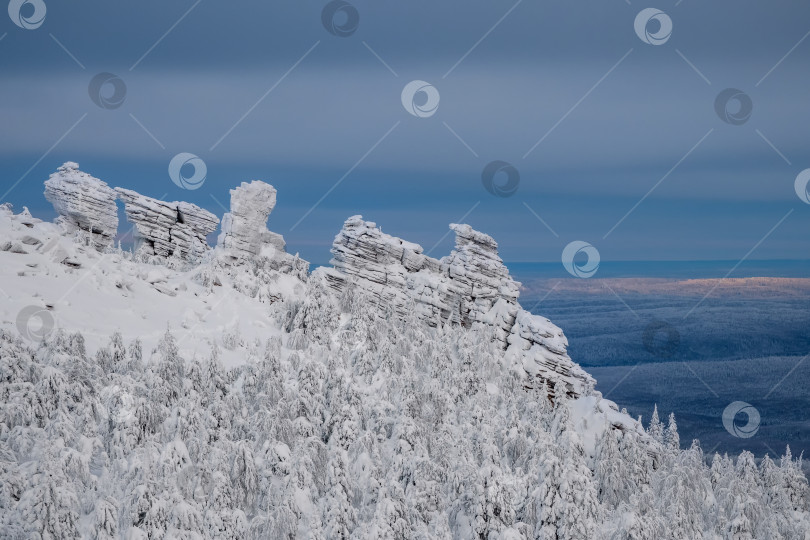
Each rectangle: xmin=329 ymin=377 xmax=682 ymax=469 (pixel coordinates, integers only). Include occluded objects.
xmin=0 ymin=163 xmax=810 ymax=540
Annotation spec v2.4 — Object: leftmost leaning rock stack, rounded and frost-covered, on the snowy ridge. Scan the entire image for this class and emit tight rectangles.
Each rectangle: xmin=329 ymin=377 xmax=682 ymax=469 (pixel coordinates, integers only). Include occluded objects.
xmin=45 ymin=161 xmax=118 ymax=250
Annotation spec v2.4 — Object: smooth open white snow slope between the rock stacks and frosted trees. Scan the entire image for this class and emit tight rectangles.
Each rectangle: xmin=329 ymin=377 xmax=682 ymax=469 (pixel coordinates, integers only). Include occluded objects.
xmin=0 ymin=200 xmax=305 ymax=366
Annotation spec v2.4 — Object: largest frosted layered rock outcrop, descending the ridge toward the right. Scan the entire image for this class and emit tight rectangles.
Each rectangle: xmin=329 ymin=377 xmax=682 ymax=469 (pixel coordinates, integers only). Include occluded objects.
xmin=325 ymin=216 xmax=595 ymax=396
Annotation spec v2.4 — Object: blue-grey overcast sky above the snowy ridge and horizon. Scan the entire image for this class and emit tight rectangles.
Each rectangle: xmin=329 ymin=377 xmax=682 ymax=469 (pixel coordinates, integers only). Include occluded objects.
xmin=0 ymin=0 xmax=810 ymax=263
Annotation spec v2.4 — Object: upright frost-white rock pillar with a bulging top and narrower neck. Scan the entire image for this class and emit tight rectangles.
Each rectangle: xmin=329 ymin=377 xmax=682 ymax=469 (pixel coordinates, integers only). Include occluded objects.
xmin=217 ymin=180 xmax=309 ymax=279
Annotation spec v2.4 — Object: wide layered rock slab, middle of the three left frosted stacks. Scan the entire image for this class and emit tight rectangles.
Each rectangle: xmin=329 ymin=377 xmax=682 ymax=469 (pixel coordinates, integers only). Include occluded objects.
xmin=115 ymin=188 xmax=219 ymax=260
